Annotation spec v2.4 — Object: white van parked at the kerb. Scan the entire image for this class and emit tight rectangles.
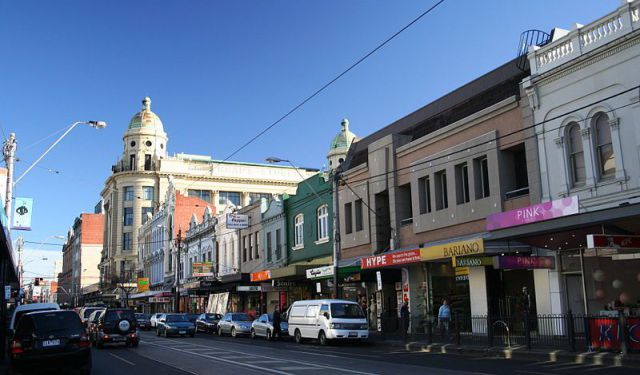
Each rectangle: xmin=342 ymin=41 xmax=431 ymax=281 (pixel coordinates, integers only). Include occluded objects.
xmin=287 ymin=299 xmax=369 ymax=345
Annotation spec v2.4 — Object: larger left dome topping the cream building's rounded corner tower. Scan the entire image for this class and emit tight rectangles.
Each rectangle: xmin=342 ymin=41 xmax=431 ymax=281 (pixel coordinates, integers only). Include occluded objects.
xmin=122 ymin=97 xmax=168 ymax=171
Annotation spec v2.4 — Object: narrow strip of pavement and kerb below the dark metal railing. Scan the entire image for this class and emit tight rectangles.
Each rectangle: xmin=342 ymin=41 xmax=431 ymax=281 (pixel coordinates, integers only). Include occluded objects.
xmin=369 ymin=334 xmax=640 ymax=368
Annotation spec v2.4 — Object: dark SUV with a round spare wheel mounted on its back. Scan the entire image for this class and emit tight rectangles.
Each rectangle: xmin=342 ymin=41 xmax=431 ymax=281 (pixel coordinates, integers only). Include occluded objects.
xmin=95 ymin=308 xmax=140 ymax=349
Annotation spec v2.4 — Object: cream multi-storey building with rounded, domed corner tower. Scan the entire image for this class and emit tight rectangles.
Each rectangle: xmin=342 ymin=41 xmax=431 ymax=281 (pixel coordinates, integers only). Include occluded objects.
xmin=100 ymin=97 xmax=317 ymax=286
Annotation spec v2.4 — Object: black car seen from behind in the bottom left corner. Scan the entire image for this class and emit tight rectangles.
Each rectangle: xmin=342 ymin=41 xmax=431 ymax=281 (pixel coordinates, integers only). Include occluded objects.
xmin=10 ymin=310 xmax=91 ymax=375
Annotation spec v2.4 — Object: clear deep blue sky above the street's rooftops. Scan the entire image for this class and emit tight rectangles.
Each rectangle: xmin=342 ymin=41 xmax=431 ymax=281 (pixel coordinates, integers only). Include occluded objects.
xmin=0 ymin=0 xmax=620 ymax=280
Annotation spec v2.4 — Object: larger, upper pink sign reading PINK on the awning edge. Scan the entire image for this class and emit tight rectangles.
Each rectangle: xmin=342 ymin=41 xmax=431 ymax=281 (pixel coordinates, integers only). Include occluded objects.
xmin=486 ymin=196 xmax=580 ymax=230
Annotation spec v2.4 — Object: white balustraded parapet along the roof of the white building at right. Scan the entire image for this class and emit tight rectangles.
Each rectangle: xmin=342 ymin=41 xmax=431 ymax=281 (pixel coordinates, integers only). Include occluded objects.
xmin=528 ymin=0 xmax=640 ymax=75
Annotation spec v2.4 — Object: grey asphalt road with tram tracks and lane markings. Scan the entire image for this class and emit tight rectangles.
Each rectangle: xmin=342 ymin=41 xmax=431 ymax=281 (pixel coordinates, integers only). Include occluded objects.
xmin=87 ymin=332 xmax=635 ymax=375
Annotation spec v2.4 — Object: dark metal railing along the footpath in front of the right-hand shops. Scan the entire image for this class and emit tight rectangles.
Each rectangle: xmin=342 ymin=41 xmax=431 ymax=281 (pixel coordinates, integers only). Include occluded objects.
xmin=400 ymin=313 xmax=640 ymax=353
